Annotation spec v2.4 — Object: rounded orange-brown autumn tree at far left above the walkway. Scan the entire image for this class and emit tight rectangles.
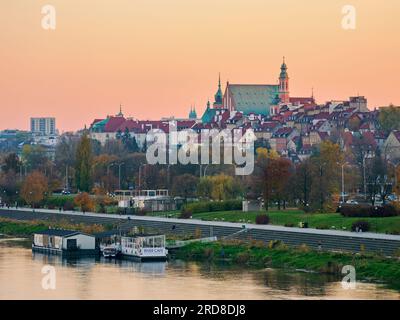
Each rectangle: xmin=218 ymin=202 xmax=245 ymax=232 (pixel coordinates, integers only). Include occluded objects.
xmin=21 ymin=171 xmax=48 ymax=206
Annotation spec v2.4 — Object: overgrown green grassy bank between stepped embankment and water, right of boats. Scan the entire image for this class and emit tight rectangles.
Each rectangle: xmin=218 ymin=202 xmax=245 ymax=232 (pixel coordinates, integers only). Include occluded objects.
xmin=175 ymin=241 xmax=400 ymax=291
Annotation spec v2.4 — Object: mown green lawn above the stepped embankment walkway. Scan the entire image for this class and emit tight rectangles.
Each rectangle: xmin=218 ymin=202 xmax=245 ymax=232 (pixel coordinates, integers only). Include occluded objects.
xmin=189 ymin=210 xmax=400 ymax=234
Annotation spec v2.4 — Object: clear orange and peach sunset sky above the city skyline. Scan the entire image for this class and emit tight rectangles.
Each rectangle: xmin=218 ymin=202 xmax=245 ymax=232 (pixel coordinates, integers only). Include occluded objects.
xmin=0 ymin=0 xmax=400 ymax=132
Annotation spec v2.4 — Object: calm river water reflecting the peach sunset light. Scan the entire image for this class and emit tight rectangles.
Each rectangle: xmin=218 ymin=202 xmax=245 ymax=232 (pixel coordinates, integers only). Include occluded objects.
xmin=0 ymin=239 xmax=400 ymax=300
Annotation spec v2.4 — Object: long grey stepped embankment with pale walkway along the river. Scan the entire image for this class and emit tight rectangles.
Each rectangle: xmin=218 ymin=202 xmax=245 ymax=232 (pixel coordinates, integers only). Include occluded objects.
xmin=0 ymin=208 xmax=400 ymax=255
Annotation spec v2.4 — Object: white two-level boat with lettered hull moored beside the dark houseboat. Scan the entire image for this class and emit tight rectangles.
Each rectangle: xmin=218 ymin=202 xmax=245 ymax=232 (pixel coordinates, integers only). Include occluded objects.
xmin=121 ymin=235 xmax=168 ymax=261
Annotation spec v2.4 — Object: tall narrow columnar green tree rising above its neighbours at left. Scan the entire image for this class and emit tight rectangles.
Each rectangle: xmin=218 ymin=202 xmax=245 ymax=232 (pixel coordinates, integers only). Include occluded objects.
xmin=75 ymin=133 xmax=93 ymax=192
